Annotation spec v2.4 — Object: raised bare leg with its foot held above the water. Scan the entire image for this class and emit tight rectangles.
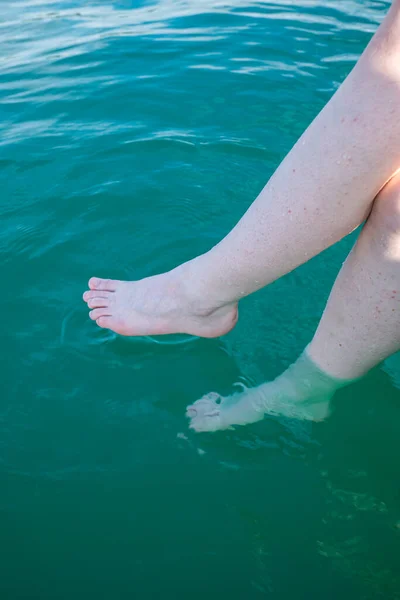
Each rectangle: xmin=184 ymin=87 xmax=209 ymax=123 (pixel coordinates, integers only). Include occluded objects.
xmin=84 ymin=0 xmax=400 ymax=337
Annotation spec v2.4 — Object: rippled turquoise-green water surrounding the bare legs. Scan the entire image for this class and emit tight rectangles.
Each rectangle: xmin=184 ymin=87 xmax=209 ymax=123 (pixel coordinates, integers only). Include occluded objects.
xmin=0 ymin=0 xmax=400 ymax=600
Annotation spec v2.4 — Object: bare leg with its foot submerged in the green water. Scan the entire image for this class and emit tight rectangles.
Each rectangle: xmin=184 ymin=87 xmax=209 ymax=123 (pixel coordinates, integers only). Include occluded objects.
xmin=187 ymin=175 xmax=400 ymax=431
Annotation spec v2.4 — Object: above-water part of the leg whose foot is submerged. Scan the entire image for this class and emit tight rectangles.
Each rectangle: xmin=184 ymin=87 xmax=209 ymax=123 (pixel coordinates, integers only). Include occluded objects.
xmin=309 ymin=174 xmax=400 ymax=378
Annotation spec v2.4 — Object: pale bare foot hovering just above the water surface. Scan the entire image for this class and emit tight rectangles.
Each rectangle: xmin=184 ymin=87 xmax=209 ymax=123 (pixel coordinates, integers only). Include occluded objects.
xmin=83 ymin=263 xmax=238 ymax=338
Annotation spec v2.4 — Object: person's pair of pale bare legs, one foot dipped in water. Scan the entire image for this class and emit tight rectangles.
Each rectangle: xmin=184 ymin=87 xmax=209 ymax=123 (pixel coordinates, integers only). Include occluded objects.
xmin=84 ymin=0 xmax=400 ymax=431
